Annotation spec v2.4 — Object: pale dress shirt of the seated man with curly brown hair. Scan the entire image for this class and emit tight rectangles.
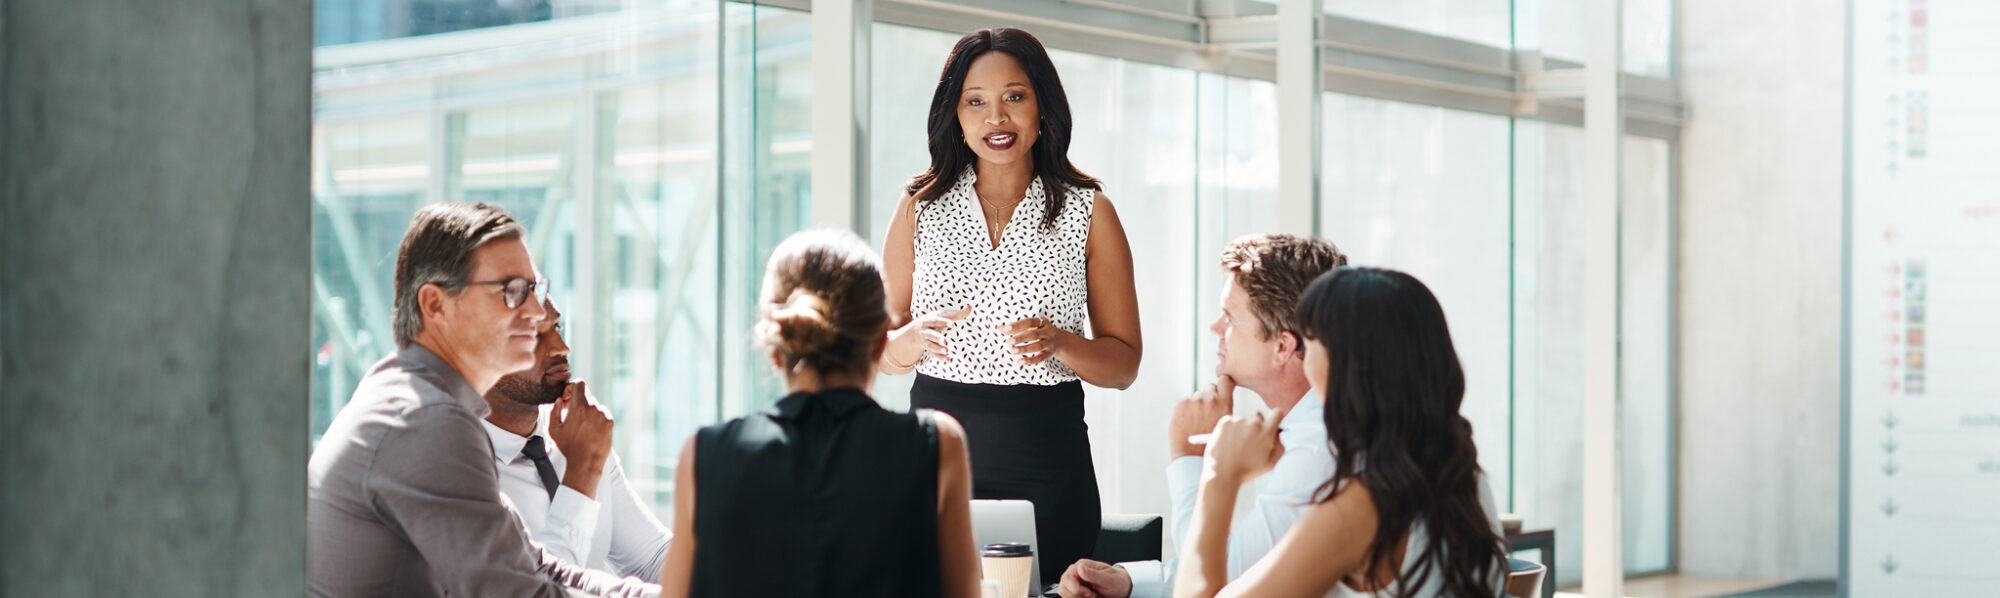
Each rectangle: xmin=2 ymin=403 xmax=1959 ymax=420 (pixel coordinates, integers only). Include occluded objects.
xmin=1118 ymin=392 xmax=1334 ymax=598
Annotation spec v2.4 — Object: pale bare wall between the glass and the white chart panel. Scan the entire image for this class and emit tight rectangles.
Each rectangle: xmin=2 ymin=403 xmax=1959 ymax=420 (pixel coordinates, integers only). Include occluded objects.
xmin=1672 ymin=0 xmax=1846 ymax=578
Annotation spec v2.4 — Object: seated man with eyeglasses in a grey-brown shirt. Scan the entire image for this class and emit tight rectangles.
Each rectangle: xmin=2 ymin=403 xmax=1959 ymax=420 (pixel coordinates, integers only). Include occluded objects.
xmin=306 ymin=202 xmax=660 ymax=596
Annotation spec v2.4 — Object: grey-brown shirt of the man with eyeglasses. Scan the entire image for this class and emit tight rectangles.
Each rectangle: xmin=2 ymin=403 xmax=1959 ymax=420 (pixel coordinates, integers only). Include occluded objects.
xmin=306 ymin=342 xmax=660 ymax=598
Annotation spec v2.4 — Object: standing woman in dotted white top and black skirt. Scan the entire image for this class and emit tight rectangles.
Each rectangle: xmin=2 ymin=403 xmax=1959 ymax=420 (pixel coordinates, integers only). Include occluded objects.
xmin=882 ymin=28 xmax=1140 ymax=584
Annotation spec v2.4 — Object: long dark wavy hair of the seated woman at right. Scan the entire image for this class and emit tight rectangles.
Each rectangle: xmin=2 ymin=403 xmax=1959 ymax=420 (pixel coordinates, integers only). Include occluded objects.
xmin=1296 ymin=268 xmax=1504 ymax=596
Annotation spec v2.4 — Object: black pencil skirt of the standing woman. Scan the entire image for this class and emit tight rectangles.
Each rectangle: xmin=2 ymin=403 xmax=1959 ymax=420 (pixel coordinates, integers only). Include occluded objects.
xmin=910 ymin=374 xmax=1102 ymax=584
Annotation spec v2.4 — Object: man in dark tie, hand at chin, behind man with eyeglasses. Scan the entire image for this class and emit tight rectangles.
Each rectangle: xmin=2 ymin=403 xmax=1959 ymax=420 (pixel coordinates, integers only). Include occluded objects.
xmin=484 ymin=300 xmax=672 ymax=582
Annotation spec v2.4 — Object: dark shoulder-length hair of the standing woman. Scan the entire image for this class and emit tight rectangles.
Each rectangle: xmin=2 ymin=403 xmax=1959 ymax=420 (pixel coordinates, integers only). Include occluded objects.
xmin=902 ymin=28 xmax=1104 ymax=230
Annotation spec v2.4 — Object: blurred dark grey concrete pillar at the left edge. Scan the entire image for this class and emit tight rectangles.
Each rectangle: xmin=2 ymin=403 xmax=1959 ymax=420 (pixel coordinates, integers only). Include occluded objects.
xmin=0 ymin=0 xmax=312 ymax=596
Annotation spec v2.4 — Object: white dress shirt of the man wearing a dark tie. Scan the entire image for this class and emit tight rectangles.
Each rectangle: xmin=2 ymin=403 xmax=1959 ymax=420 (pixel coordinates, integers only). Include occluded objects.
xmin=480 ymin=408 xmax=672 ymax=582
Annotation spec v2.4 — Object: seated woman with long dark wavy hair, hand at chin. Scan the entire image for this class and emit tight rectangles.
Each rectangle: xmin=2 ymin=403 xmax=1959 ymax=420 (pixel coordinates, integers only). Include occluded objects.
xmin=1176 ymin=268 xmax=1506 ymax=596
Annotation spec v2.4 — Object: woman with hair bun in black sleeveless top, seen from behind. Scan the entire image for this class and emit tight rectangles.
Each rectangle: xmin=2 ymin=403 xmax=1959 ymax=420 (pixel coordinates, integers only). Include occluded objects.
xmin=660 ymin=230 xmax=980 ymax=596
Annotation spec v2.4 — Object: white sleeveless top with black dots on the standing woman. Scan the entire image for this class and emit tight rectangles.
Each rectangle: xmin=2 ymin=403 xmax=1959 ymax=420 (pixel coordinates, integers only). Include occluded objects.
xmin=910 ymin=166 xmax=1096 ymax=386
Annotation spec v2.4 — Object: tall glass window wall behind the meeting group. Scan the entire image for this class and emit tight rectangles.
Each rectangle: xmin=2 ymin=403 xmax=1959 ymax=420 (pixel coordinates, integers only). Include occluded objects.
xmin=310 ymin=0 xmax=1680 ymax=584
